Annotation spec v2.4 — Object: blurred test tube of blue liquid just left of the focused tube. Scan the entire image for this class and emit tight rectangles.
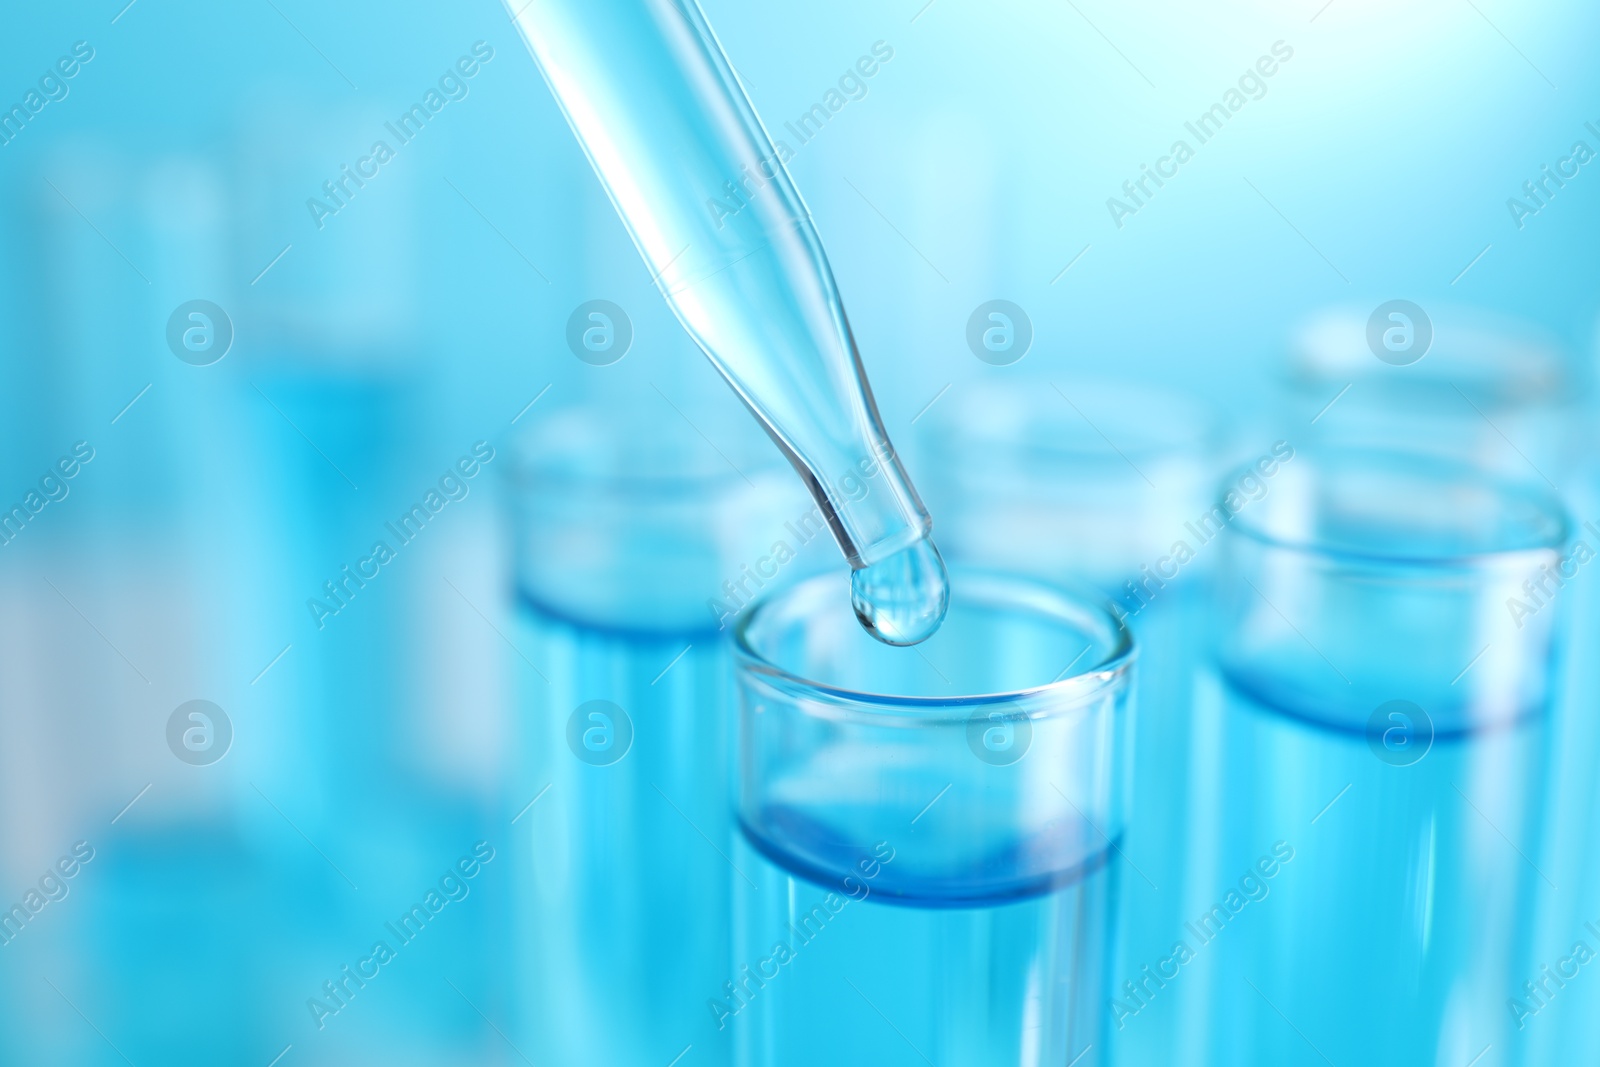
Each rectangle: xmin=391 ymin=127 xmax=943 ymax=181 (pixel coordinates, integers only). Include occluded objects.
xmin=506 ymin=408 xmax=806 ymax=1064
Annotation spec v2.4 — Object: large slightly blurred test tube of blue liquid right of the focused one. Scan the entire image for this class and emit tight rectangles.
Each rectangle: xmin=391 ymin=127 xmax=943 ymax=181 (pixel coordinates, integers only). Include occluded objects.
xmin=1203 ymin=448 xmax=1570 ymax=1065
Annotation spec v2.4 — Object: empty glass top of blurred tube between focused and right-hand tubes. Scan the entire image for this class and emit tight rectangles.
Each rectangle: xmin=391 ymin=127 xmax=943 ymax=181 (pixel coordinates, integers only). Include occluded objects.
xmin=920 ymin=381 xmax=1222 ymax=588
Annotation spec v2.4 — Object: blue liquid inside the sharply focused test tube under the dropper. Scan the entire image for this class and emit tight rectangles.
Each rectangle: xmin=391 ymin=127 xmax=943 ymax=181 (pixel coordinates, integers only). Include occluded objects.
xmin=726 ymin=816 xmax=1115 ymax=1067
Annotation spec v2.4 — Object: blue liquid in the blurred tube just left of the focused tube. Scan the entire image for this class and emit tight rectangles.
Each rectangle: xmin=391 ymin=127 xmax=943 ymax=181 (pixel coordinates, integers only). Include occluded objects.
xmin=512 ymin=601 xmax=736 ymax=1065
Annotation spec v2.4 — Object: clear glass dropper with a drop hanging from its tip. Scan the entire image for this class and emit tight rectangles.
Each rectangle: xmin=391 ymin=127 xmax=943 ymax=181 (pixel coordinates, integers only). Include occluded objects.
xmin=506 ymin=0 xmax=946 ymax=643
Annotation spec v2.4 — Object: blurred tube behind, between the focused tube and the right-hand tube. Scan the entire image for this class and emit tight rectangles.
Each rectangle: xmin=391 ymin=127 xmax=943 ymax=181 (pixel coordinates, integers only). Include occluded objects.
xmin=920 ymin=382 xmax=1216 ymax=1064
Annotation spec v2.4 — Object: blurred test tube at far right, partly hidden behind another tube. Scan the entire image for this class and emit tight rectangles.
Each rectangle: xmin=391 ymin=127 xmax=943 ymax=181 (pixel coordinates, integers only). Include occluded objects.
xmin=1286 ymin=301 xmax=1600 ymax=1062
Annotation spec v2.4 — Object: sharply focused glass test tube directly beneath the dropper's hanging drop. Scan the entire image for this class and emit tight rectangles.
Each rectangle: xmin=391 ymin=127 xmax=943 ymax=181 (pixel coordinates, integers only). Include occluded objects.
xmin=726 ymin=569 xmax=1134 ymax=1067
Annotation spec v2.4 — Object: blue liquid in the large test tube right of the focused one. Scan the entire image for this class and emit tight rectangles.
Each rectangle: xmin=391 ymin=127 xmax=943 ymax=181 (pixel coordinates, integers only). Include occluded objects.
xmin=1203 ymin=678 xmax=1546 ymax=1067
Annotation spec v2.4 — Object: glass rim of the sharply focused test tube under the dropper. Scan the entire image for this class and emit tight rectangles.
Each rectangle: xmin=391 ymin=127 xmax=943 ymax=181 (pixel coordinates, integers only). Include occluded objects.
xmin=733 ymin=566 xmax=1139 ymax=716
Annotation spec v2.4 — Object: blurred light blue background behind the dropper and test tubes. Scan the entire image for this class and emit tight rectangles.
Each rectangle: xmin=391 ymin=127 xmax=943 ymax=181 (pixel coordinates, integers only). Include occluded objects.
xmin=0 ymin=0 xmax=1600 ymax=1065
